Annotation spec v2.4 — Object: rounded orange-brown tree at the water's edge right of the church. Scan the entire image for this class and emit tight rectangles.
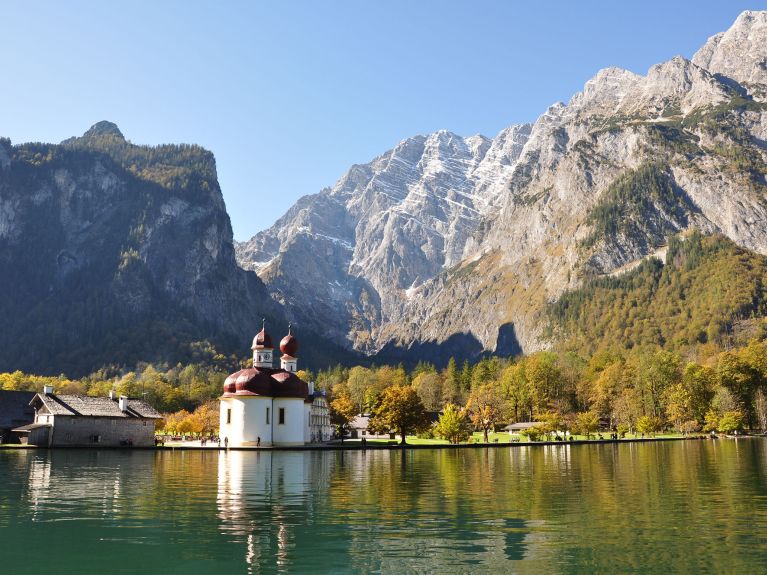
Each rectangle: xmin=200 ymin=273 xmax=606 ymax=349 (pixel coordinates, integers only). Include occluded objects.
xmin=368 ymin=385 xmax=429 ymax=445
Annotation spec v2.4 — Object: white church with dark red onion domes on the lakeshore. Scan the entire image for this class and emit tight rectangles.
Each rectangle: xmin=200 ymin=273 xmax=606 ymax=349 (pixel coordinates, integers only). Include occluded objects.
xmin=219 ymin=322 xmax=333 ymax=447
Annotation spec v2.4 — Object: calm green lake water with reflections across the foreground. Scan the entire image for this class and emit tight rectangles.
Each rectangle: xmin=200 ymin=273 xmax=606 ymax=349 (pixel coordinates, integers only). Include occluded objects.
xmin=0 ymin=438 xmax=767 ymax=575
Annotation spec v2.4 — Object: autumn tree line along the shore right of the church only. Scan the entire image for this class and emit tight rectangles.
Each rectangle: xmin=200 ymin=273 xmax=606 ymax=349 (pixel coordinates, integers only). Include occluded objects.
xmin=317 ymin=332 xmax=767 ymax=440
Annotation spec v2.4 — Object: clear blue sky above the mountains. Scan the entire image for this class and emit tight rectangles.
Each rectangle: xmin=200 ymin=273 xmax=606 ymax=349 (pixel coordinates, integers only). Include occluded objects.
xmin=0 ymin=0 xmax=767 ymax=240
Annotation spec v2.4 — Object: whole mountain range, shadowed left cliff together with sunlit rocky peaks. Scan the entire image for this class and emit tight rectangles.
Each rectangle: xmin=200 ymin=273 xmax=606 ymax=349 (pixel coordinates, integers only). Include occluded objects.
xmin=0 ymin=12 xmax=767 ymax=375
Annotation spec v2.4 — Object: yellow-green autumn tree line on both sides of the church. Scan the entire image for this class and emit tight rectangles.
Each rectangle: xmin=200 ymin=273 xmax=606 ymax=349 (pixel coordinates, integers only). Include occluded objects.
xmin=6 ymin=332 xmax=767 ymax=441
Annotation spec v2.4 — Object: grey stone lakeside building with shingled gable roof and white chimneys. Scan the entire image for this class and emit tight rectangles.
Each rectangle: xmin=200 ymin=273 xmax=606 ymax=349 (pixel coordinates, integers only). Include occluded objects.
xmin=14 ymin=386 xmax=162 ymax=447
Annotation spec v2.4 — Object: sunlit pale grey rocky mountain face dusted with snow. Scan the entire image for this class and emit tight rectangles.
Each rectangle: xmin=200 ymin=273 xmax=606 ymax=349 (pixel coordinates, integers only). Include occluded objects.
xmin=236 ymin=12 xmax=767 ymax=364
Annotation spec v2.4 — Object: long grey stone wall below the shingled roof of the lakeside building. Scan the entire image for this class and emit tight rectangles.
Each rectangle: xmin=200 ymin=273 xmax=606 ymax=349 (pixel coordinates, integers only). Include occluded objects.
xmin=43 ymin=415 xmax=154 ymax=447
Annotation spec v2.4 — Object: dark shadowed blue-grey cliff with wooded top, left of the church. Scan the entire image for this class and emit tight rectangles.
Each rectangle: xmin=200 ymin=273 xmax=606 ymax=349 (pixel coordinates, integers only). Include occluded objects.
xmin=0 ymin=122 xmax=292 ymax=375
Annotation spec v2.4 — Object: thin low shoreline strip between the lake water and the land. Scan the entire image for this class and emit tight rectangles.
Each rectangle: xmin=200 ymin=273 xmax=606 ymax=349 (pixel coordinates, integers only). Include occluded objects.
xmin=0 ymin=435 xmax=762 ymax=452
